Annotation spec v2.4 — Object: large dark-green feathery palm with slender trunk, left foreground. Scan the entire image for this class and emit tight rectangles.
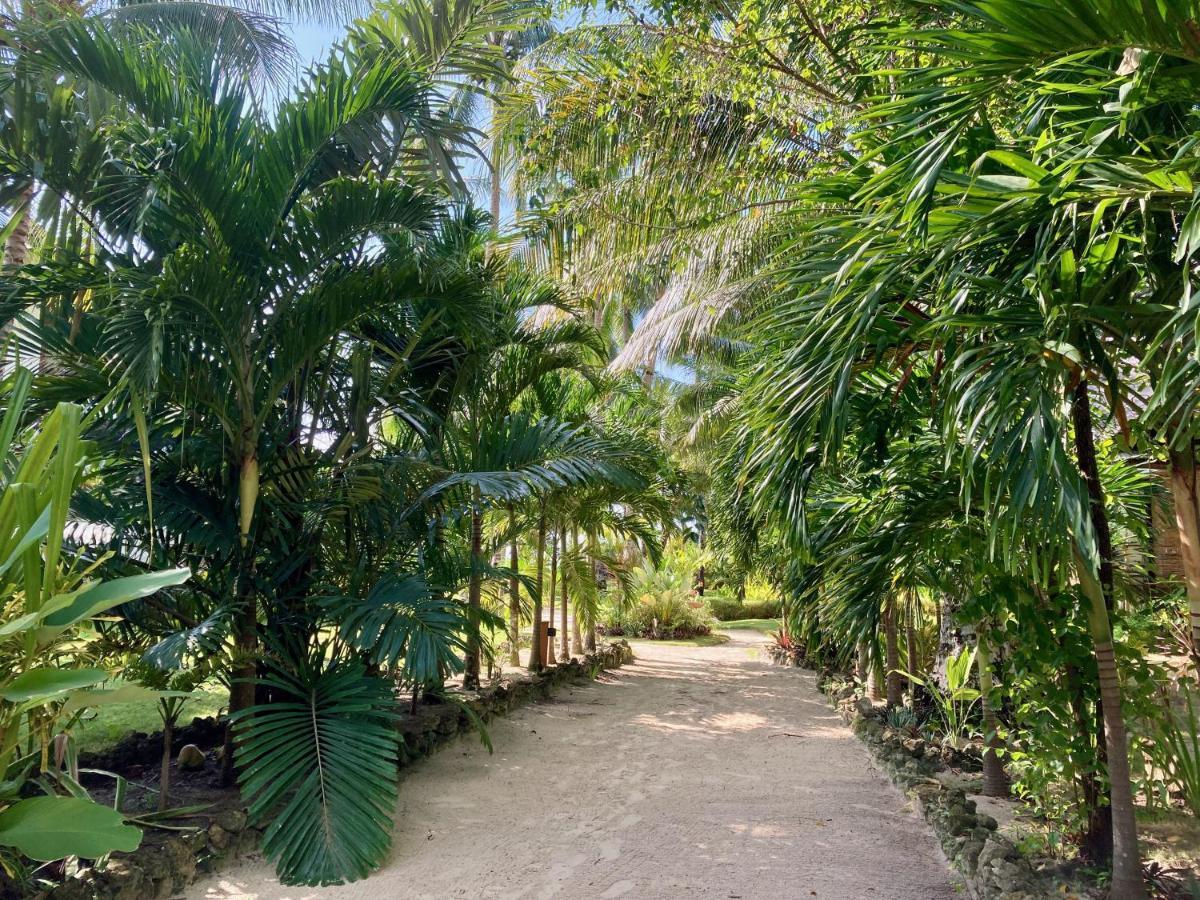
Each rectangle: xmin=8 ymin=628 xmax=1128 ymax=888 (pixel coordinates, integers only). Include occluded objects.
xmin=0 ymin=20 xmax=494 ymax=777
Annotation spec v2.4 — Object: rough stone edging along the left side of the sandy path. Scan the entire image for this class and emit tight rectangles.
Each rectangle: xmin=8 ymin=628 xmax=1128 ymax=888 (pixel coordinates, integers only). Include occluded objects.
xmin=40 ymin=641 xmax=634 ymax=900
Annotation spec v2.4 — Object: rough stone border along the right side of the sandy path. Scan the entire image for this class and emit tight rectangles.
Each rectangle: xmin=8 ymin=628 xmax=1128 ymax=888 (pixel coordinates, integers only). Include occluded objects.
xmin=817 ymin=673 xmax=1070 ymax=900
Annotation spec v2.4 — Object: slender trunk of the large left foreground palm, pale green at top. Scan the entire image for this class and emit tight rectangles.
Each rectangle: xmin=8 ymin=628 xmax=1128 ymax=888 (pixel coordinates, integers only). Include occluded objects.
xmin=221 ymin=451 xmax=259 ymax=787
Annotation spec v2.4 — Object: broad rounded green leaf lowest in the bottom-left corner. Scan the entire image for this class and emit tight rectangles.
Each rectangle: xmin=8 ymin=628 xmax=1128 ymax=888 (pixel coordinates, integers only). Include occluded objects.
xmin=0 ymin=797 xmax=142 ymax=862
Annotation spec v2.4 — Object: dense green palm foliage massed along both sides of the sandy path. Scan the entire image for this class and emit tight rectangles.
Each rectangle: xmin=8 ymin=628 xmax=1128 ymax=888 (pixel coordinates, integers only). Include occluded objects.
xmin=0 ymin=0 xmax=1200 ymax=898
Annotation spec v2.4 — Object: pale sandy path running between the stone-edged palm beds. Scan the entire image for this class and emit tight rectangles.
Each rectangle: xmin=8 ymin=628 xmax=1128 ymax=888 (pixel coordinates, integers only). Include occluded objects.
xmin=188 ymin=631 xmax=956 ymax=900
